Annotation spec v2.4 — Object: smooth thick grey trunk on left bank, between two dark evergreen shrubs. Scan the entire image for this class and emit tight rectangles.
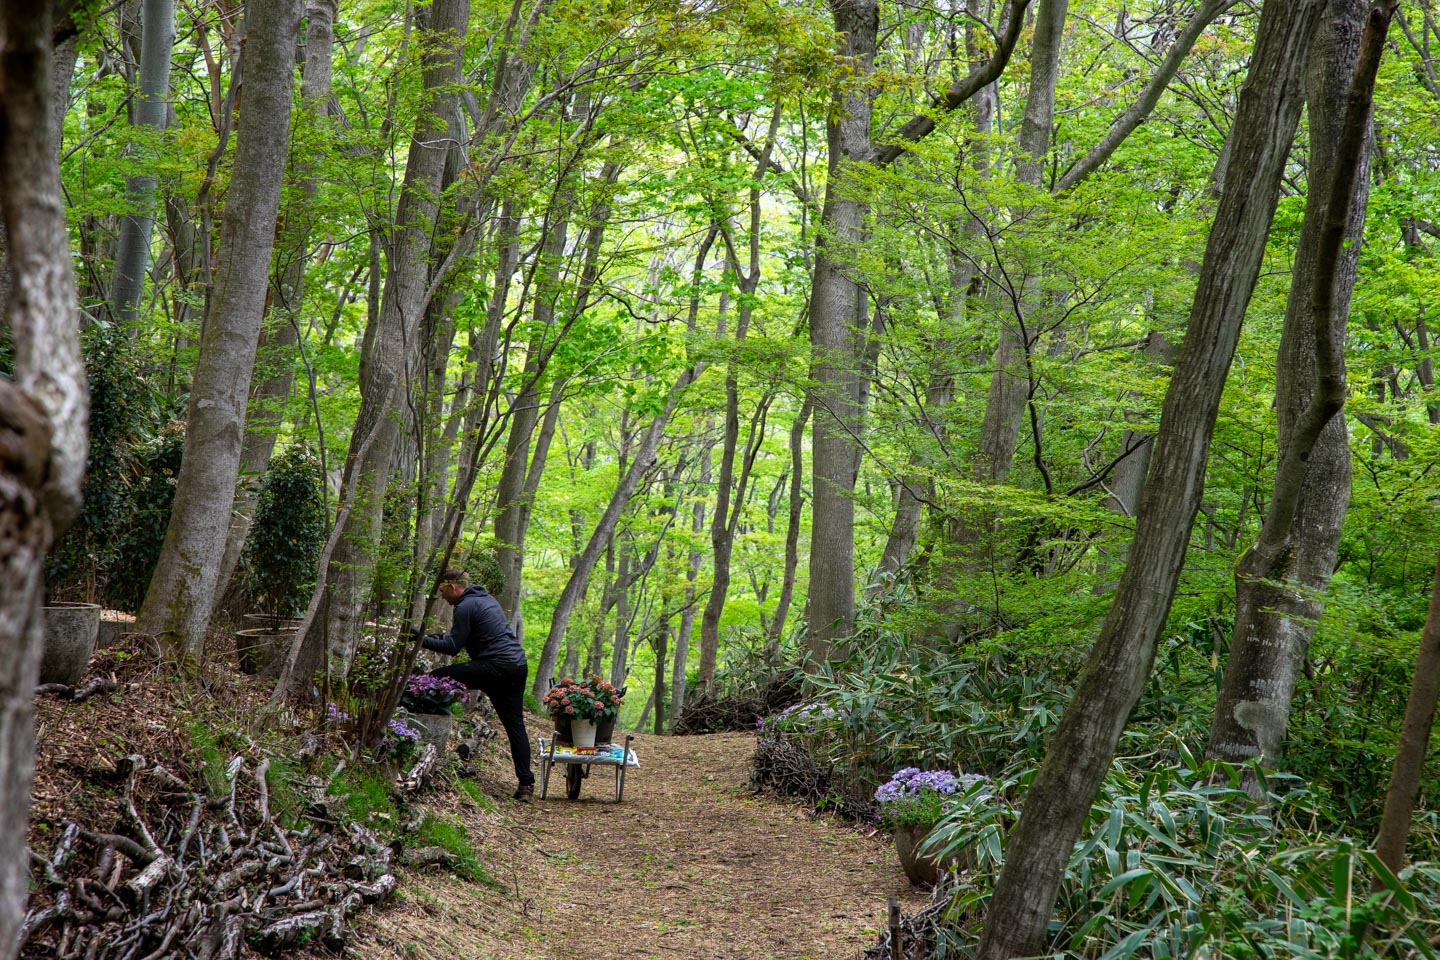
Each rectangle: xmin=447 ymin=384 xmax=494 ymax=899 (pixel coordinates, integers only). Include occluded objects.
xmin=137 ymin=0 xmax=300 ymax=669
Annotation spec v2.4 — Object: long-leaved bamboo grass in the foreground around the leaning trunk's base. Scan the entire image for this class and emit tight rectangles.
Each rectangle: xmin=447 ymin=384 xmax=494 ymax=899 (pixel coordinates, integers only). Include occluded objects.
xmin=930 ymin=751 xmax=1440 ymax=960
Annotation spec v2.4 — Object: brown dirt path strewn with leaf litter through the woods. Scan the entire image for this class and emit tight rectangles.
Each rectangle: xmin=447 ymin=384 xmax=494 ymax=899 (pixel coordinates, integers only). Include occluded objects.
xmin=360 ymin=734 xmax=924 ymax=960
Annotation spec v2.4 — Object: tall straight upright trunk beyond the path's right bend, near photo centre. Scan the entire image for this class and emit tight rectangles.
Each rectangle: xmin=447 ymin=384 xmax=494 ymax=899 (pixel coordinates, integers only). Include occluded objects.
xmin=806 ymin=0 xmax=880 ymax=666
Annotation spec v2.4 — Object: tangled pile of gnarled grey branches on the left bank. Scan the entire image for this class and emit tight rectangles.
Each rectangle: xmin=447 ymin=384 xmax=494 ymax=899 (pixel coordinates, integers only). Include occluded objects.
xmin=20 ymin=754 xmax=396 ymax=960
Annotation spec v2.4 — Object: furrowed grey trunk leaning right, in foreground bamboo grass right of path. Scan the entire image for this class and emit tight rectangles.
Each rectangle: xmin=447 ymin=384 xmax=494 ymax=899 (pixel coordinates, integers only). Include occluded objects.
xmin=979 ymin=0 xmax=1320 ymax=960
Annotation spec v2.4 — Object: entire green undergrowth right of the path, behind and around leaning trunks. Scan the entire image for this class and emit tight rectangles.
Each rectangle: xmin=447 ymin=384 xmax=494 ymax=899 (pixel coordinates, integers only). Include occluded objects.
xmin=756 ymin=620 xmax=1440 ymax=960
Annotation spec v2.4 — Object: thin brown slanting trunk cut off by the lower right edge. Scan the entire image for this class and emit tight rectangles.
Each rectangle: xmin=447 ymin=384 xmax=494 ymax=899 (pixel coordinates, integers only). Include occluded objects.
xmin=1375 ymin=544 xmax=1440 ymax=874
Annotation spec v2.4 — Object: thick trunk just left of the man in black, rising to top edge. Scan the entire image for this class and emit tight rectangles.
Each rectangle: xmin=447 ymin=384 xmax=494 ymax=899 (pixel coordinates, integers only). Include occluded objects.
xmin=281 ymin=0 xmax=484 ymax=697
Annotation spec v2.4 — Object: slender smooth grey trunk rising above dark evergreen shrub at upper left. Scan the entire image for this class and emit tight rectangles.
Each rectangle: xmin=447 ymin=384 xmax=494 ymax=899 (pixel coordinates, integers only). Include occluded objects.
xmin=109 ymin=0 xmax=174 ymax=327
